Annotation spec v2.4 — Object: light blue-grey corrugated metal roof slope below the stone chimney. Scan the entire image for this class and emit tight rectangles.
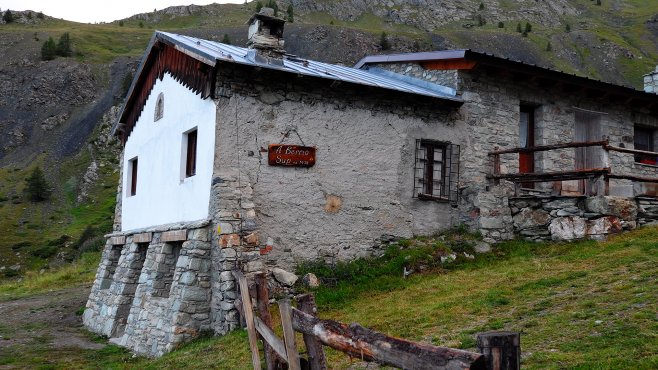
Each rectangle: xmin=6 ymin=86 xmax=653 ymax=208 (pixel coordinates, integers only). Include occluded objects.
xmin=156 ymin=31 xmax=462 ymax=102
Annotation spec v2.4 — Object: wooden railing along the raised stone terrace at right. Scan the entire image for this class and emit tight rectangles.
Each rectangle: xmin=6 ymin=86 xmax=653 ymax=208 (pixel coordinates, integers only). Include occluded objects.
xmin=487 ymin=140 xmax=658 ymax=195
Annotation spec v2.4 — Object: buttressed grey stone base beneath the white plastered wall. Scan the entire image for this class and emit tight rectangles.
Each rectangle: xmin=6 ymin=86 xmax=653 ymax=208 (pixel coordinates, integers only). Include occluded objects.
xmin=83 ymin=225 xmax=213 ymax=356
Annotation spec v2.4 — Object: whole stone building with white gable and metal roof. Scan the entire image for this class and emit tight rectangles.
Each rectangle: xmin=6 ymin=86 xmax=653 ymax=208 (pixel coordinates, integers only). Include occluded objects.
xmin=83 ymin=7 xmax=658 ymax=356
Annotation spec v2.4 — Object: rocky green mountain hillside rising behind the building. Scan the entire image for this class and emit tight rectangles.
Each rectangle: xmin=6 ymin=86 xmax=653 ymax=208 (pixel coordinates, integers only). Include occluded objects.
xmin=0 ymin=0 xmax=658 ymax=276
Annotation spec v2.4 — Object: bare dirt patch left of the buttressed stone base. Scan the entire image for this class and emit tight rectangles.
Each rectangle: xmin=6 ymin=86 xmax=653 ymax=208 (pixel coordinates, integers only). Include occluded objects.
xmin=0 ymin=286 xmax=105 ymax=358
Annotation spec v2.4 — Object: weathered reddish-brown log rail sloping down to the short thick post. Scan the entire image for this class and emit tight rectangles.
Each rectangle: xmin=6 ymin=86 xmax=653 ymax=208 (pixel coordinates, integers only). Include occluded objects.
xmin=292 ymin=308 xmax=486 ymax=370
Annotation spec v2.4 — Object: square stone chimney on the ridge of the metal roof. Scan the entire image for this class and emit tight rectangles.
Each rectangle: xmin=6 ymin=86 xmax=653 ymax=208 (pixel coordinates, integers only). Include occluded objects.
xmin=247 ymin=8 xmax=286 ymax=64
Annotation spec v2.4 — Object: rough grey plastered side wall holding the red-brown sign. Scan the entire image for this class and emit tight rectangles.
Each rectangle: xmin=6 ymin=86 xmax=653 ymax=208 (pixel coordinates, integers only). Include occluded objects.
xmin=213 ymin=64 xmax=469 ymax=268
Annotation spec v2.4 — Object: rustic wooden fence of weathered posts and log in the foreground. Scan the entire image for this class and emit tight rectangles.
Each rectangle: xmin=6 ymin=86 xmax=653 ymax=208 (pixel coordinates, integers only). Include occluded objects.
xmin=233 ymin=271 xmax=490 ymax=370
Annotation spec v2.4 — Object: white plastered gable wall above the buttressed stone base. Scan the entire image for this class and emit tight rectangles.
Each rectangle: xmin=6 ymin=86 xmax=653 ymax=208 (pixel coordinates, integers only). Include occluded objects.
xmin=121 ymin=73 xmax=216 ymax=231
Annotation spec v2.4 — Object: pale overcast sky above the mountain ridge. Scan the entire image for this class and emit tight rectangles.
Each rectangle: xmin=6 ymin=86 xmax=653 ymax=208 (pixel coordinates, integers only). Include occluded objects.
xmin=0 ymin=0 xmax=243 ymax=23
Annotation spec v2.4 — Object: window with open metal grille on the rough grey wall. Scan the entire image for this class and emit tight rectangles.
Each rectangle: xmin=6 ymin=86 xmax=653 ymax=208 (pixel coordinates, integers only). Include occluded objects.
xmin=414 ymin=139 xmax=459 ymax=204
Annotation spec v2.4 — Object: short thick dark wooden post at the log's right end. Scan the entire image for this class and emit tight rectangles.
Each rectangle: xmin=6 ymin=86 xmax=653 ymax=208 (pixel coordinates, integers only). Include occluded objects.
xmin=477 ymin=331 xmax=521 ymax=370
